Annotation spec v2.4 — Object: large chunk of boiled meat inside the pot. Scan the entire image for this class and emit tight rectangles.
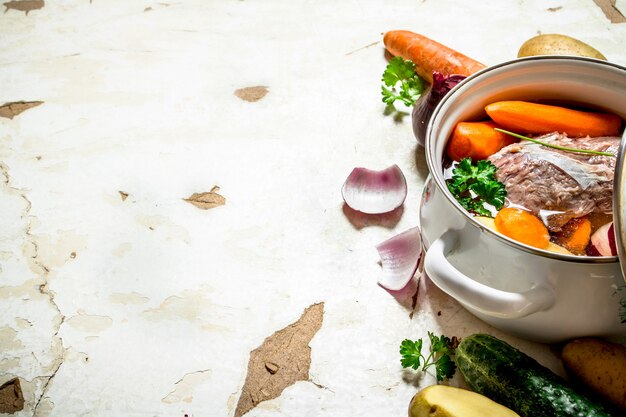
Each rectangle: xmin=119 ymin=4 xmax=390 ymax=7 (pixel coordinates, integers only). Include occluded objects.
xmin=489 ymin=133 xmax=620 ymax=231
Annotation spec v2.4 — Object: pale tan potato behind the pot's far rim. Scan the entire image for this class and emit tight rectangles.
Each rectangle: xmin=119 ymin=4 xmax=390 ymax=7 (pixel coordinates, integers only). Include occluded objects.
xmin=517 ymin=34 xmax=606 ymax=61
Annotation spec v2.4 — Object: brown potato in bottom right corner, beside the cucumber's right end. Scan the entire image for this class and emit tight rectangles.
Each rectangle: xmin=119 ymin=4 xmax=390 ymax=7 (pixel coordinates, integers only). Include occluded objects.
xmin=562 ymin=337 xmax=626 ymax=412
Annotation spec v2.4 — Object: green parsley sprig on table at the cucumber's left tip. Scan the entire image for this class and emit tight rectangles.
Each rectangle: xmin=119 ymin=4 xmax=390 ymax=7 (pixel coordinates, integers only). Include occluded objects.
xmin=400 ymin=332 xmax=458 ymax=381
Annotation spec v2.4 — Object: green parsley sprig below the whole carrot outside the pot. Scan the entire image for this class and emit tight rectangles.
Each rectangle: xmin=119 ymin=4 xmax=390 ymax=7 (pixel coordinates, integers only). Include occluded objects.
xmin=382 ymin=56 xmax=424 ymax=107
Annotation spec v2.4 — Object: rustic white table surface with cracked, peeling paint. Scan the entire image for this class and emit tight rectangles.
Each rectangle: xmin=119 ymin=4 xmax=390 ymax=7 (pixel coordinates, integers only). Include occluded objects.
xmin=0 ymin=0 xmax=626 ymax=417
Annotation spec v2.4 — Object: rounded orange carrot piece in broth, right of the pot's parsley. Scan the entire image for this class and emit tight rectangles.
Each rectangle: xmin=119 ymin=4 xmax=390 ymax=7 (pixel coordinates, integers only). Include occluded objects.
xmin=495 ymin=207 xmax=550 ymax=249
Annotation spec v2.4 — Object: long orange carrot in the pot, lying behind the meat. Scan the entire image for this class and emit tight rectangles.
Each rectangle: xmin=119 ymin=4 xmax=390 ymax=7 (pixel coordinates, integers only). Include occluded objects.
xmin=485 ymin=101 xmax=622 ymax=137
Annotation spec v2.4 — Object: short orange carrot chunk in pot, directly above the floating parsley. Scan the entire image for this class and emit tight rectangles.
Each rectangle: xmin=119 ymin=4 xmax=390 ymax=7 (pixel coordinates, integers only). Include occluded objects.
xmin=446 ymin=122 xmax=517 ymax=161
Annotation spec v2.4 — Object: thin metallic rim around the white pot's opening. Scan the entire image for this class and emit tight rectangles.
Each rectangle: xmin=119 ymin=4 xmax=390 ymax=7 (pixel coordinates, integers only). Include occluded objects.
xmin=424 ymin=55 xmax=626 ymax=264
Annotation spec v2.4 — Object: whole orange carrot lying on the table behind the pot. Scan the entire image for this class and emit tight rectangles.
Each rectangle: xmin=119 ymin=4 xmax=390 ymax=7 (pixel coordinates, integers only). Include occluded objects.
xmin=383 ymin=30 xmax=485 ymax=84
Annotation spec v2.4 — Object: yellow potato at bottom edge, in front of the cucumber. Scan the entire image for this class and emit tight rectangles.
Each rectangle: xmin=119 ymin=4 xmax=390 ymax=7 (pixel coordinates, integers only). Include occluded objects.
xmin=409 ymin=385 xmax=519 ymax=417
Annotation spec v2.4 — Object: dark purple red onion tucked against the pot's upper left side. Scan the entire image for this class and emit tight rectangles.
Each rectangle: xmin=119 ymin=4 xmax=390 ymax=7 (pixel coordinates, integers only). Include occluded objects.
xmin=411 ymin=72 xmax=467 ymax=146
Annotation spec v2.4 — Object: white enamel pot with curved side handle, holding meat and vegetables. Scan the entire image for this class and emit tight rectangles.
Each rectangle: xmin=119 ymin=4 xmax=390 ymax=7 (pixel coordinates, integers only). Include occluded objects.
xmin=420 ymin=56 xmax=626 ymax=343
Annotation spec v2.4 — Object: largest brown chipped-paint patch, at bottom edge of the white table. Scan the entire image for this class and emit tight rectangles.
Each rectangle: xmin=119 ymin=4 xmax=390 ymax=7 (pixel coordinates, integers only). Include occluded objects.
xmin=235 ymin=303 xmax=324 ymax=417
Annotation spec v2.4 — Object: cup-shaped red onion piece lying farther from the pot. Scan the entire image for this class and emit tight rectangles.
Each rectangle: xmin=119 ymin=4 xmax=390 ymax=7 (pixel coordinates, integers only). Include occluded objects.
xmin=341 ymin=164 xmax=407 ymax=214
